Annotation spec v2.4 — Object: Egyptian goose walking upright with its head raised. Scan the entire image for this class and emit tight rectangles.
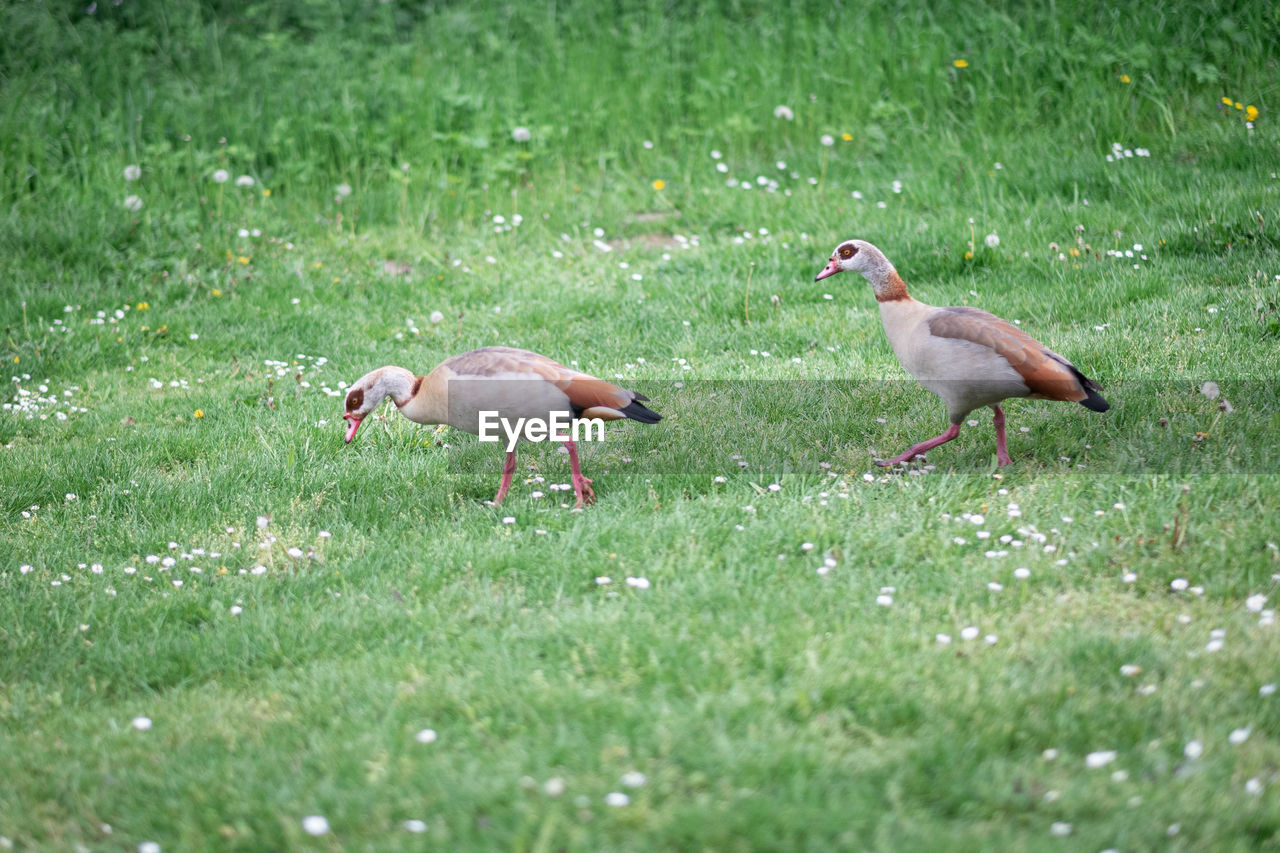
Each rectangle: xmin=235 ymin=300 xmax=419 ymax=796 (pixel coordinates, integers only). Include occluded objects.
xmin=814 ymin=240 xmax=1111 ymax=465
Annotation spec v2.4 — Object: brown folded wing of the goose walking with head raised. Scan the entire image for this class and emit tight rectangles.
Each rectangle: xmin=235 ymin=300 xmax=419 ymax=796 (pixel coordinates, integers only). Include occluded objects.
xmin=929 ymin=305 xmax=1088 ymax=402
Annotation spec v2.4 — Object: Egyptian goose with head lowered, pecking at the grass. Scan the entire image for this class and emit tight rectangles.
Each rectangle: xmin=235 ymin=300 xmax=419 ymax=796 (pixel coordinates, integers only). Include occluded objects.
xmin=343 ymin=347 xmax=662 ymax=508
